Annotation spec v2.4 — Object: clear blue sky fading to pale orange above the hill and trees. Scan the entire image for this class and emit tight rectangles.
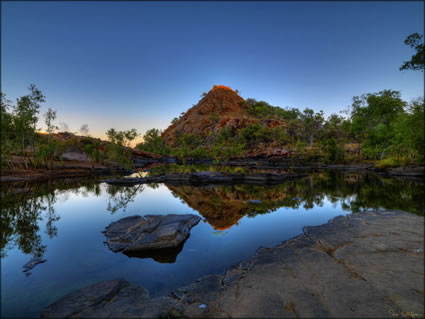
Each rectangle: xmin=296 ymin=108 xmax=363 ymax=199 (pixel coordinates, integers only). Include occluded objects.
xmin=1 ymin=1 xmax=424 ymax=142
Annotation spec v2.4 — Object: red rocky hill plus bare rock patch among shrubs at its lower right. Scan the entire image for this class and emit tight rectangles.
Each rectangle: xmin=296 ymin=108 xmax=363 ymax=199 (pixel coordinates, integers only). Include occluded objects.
xmin=162 ymin=85 xmax=287 ymax=156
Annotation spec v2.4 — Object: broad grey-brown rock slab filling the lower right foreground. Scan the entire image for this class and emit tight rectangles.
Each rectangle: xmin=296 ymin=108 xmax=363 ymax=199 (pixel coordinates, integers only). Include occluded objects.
xmin=41 ymin=211 xmax=424 ymax=318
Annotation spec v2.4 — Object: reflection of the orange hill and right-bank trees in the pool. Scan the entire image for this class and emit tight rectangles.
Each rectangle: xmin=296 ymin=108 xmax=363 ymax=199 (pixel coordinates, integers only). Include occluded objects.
xmin=167 ymin=171 xmax=424 ymax=230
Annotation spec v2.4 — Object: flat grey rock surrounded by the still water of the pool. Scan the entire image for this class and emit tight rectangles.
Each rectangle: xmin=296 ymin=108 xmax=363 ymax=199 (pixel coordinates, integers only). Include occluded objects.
xmin=104 ymin=214 xmax=201 ymax=254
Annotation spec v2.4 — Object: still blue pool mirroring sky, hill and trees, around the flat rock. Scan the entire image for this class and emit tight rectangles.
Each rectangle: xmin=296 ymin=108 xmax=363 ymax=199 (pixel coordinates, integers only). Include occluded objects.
xmin=1 ymin=172 xmax=424 ymax=317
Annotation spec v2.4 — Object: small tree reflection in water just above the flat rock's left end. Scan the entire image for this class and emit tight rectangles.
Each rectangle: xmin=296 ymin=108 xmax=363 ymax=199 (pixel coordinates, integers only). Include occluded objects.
xmin=106 ymin=184 xmax=144 ymax=214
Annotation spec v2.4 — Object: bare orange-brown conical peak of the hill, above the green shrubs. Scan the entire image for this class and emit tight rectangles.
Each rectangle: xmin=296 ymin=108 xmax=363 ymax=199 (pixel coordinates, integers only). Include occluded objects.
xmin=162 ymin=85 xmax=285 ymax=147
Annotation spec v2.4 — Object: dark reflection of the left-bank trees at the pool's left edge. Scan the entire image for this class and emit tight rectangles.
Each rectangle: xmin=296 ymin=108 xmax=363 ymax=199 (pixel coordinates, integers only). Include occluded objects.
xmin=0 ymin=179 xmax=100 ymax=257
